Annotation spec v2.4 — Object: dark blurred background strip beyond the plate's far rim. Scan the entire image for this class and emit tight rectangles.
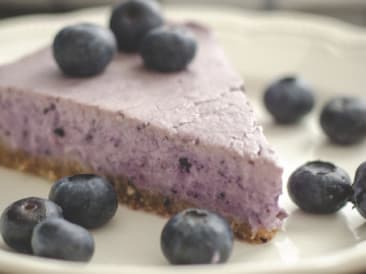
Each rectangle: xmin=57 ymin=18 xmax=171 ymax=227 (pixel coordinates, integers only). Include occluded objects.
xmin=0 ymin=0 xmax=366 ymax=26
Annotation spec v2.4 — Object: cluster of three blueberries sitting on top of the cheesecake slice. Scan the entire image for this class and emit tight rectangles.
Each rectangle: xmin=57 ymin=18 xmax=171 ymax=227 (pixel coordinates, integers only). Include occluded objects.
xmin=52 ymin=0 xmax=197 ymax=77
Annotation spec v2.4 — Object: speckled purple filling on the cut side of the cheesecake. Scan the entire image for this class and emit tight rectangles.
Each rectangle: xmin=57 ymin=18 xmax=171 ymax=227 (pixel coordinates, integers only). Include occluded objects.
xmin=0 ymin=89 xmax=281 ymax=228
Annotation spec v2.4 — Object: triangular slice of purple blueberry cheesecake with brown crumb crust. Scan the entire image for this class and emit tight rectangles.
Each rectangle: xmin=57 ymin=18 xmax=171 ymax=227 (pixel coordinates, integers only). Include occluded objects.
xmin=0 ymin=24 xmax=284 ymax=242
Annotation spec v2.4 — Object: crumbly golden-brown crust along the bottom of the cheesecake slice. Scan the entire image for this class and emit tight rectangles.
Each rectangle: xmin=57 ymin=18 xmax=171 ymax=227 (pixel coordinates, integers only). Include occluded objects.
xmin=0 ymin=144 xmax=277 ymax=243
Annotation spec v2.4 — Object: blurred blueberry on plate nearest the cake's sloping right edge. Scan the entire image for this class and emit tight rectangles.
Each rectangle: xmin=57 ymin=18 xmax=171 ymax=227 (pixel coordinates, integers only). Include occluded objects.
xmin=264 ymin=76 xmax=314 ymax=124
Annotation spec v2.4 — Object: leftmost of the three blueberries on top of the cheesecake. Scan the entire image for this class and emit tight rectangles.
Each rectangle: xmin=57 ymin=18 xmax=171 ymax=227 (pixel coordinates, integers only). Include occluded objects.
xmin=53 ymin=24 xmax=117 ymax=77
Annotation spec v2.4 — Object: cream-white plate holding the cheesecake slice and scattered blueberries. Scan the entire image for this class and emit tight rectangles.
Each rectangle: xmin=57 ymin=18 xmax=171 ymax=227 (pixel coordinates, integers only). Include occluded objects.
xmin=0 ymin=4 xmax=366 ymax=274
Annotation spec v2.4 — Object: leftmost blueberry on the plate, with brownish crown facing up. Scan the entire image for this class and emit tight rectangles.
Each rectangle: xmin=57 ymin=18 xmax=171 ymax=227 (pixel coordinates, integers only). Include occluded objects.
xmin=0 ymin=197 xmax=62 ymax=253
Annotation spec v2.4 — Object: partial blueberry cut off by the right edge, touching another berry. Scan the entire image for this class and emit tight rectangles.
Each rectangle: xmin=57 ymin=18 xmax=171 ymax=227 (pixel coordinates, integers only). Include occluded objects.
xmin=352 ymin=162 xmax=366 ymax=218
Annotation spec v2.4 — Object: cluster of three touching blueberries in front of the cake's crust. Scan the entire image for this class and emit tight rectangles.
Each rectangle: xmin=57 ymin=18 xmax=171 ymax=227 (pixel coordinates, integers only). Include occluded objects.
xmin=0 ymin=174 xmax=118 ymax=261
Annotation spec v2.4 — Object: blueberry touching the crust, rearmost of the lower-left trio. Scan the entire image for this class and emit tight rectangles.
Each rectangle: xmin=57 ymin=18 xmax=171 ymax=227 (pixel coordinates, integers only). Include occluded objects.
xmin=49 ymin=174 xmax=118 ymax=228
